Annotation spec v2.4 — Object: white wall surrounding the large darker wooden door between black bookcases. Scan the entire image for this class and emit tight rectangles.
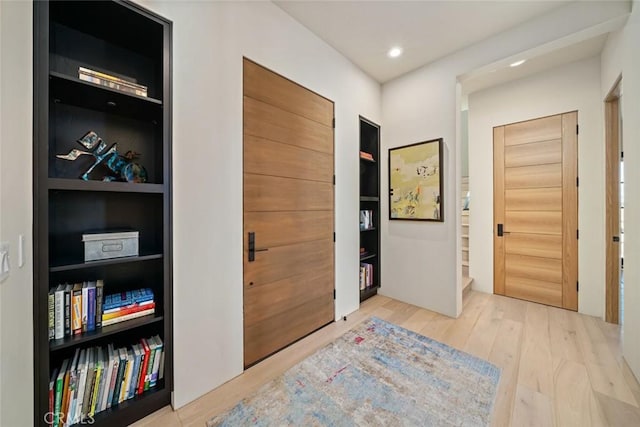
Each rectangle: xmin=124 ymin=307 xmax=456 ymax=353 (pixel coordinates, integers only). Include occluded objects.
xmin=145 ymin=1 xmax=381 ymax=407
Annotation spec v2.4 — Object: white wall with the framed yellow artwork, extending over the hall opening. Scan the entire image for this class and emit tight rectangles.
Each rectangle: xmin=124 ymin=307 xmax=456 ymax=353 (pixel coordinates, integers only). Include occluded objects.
xmin=381 ymin=2 xmax=629 ymax=316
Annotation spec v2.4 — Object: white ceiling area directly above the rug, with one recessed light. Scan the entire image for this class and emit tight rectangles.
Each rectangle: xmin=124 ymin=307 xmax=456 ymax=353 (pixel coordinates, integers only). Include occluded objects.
xmin=274 ymin=0 xmax=569 ymax=83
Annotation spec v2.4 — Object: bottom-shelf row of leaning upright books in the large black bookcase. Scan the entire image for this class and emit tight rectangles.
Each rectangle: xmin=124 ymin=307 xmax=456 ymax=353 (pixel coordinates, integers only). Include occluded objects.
xmin=47 ymin=335 xmax=165 ymax=427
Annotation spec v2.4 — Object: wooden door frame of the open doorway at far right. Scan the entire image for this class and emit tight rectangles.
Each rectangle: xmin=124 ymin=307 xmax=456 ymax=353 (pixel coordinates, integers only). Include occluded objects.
xmin=604 ymin=75 xmax=622 ymax=324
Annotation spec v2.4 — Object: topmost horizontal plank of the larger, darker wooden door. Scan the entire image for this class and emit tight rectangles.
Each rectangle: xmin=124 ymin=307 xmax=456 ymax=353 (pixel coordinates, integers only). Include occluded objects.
xmin=243 ymin=60 xmax=333 ymax=127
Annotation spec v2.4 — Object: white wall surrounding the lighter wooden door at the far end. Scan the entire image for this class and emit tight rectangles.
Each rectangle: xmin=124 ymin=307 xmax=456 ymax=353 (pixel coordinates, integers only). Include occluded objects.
xmin=469 ymin=57 xmax=605 ymax=317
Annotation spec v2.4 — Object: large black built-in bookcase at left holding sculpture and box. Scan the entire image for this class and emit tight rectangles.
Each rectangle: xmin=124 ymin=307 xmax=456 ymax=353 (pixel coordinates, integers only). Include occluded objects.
xmin=33 ymin=1 xmax=173 ymax=426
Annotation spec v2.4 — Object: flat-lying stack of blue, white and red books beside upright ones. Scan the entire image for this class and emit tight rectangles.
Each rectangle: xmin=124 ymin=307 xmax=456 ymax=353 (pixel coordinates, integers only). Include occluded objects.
xmin=102 ymin=288 xmax=156 ymax=326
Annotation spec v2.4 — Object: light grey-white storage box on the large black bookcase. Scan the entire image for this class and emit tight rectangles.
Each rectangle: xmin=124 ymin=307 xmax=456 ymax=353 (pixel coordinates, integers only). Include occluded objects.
xmin=82 ymin=231 xmax=138 ymax=262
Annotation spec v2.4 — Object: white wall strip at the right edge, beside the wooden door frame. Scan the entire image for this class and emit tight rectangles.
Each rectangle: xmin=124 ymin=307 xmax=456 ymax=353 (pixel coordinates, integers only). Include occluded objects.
xmin=601 ymin=0 xmax=640 ymax=378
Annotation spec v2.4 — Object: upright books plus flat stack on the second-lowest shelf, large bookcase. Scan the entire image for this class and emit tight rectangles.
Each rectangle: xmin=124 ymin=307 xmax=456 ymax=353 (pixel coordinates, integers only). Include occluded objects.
xmin=48 ymin=280 xmax=156 ymax=340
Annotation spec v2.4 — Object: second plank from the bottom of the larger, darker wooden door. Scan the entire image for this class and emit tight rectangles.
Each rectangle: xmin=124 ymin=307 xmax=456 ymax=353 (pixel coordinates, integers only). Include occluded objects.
xmin=244 ymin=269 xmax=333 ymax=327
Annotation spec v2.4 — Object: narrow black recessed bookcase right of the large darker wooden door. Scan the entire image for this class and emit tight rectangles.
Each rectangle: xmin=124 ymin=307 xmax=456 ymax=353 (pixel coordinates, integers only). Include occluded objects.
xmin=360 ymin=117 xmax=381 ymax=302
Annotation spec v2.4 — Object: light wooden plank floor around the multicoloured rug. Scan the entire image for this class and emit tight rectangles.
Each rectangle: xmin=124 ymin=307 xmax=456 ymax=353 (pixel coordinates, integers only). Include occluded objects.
xmin=135 ymin=291 xmax=640 ymax=427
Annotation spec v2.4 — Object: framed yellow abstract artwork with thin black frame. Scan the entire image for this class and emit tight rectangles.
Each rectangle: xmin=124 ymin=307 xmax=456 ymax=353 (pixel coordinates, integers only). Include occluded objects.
xmin=389 ymin=138 xmax=444 ymax=222
